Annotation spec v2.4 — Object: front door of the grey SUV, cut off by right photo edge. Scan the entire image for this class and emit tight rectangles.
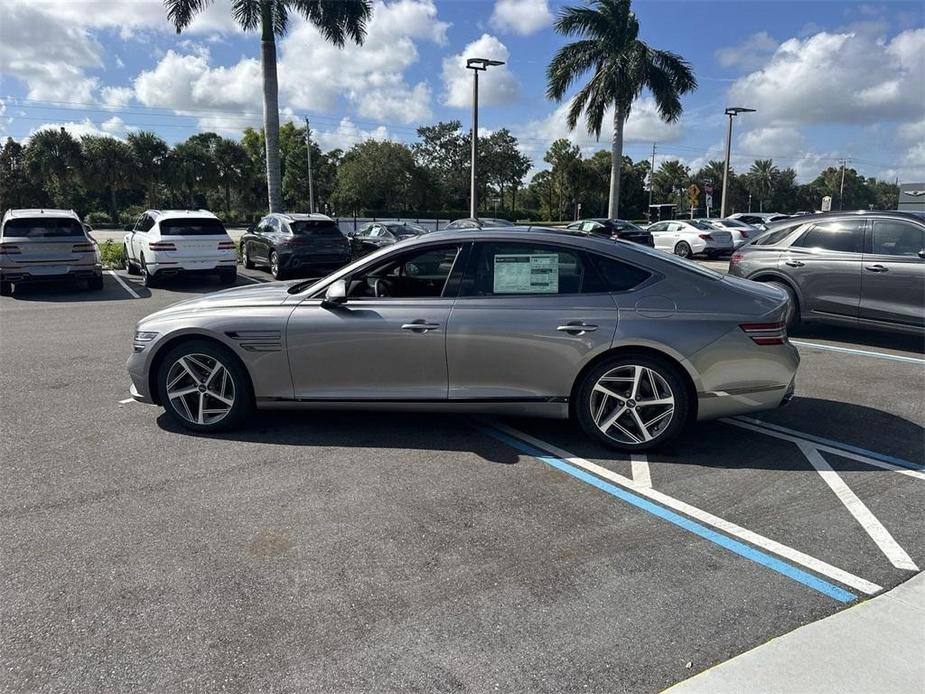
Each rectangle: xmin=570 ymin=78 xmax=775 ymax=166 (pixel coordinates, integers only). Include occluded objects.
xmin=859 ymin=219 xmax=925 ymax=328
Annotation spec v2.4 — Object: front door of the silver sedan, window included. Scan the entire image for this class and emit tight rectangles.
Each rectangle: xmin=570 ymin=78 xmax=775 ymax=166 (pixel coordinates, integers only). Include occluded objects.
xmin=286 ymin=243 xmax=468 ymax=401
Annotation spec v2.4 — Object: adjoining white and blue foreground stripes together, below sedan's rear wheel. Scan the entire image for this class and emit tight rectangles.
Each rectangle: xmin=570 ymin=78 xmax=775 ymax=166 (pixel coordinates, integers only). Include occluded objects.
xmin=483 ymin=422 xmax=883 ymax=602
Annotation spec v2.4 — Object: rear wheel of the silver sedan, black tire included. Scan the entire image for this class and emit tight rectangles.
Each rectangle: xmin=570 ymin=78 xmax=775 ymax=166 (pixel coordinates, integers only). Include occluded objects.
xmin=573 ymin=353 xmax=691 ymax=451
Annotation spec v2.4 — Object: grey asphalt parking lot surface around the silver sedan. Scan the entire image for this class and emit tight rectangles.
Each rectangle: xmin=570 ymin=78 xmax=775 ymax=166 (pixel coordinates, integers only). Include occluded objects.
xmin=0 ymin=272 xmax=925 ymax=692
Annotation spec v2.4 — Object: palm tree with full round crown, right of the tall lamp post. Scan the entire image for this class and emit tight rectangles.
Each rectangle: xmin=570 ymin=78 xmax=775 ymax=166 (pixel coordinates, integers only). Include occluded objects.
xmin=546 ymin=0 xmax=697 ymax=217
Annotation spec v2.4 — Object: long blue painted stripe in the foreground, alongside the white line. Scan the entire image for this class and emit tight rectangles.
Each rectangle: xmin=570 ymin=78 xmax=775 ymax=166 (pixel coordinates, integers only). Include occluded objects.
xmin=480 ymin=427 xmax=857 ymax=602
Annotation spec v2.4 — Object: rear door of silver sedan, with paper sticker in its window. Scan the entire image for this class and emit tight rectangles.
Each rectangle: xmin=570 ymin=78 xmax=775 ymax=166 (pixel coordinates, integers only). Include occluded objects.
xmin=446 ymin=241 xmax=617 ymax=400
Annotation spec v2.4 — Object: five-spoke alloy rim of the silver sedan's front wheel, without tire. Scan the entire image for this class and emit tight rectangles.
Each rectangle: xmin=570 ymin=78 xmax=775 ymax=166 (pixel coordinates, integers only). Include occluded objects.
xmin=167 ymin=354 xmax=235 ymax=424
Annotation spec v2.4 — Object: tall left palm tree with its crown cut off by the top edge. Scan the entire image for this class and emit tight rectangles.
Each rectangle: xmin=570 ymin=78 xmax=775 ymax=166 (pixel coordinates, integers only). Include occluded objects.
xmin=164 ymin=0 xmax=372 ymax=212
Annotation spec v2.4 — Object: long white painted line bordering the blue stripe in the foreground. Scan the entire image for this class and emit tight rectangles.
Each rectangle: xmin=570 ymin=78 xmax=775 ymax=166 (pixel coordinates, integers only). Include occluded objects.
xmin=491 ymin=422 xmax=883 ymax=595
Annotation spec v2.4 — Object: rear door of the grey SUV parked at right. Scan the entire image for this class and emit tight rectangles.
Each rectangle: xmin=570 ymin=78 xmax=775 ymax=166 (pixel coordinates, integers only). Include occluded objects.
xmin=778 ymin=217 xmax=866 ymax=319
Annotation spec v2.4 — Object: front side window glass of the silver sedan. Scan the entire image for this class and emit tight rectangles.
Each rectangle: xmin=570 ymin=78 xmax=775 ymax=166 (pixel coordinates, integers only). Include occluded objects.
xmin=348 ymin=245 xmax=460 ymax=299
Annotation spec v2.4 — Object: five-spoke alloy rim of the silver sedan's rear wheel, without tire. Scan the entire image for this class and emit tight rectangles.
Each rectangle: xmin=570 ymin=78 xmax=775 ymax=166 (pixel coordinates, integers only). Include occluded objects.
xmin=590 ymin=364 xmax=675 ymax=445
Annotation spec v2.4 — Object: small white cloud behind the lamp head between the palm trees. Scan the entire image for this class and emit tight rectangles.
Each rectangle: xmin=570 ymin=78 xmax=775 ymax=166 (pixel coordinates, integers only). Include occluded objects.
xmin=443 ymin=34 xmax=520 ymax=108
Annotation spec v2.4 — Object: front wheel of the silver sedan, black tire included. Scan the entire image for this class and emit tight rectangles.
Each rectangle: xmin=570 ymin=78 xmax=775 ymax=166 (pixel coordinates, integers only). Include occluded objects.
xmin=157 ymin=340 xmax=254 ymax=431
